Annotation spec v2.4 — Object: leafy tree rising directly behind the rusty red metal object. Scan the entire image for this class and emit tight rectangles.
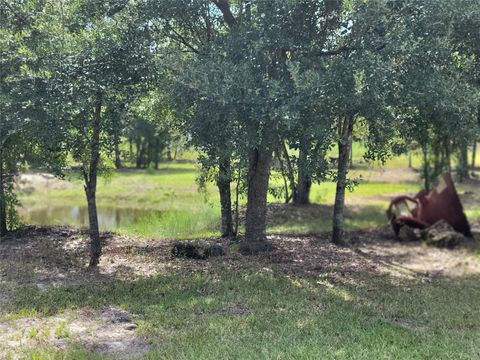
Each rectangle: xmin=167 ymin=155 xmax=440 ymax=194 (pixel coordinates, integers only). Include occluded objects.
xmin=398 ymin=1 xmax=478 ymax=190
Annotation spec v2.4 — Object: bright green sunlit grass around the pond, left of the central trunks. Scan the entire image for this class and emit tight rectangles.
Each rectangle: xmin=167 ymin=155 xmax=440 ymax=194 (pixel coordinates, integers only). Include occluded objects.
xmin=20 ymin=163 xmax=225 ymax=238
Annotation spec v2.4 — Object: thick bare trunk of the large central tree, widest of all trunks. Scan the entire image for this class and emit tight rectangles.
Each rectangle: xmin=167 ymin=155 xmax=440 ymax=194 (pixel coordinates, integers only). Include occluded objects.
xmin=240 ymin=148 xmax=272 ymax=254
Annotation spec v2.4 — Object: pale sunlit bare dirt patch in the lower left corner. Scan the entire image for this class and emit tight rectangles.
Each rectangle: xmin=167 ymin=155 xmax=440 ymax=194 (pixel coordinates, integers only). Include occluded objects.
xmin=0 ymin=308 xmax=148 ymax=359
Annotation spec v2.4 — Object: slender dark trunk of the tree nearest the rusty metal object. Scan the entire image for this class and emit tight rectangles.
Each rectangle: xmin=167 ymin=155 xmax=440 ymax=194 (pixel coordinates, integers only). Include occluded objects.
xmin=332 ymin=116 xmax=355 ymax=245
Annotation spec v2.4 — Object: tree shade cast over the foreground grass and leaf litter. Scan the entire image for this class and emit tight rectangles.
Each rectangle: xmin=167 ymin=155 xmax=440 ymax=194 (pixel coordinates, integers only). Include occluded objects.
xmin=0 ymin=226 xmax=480 ymax=359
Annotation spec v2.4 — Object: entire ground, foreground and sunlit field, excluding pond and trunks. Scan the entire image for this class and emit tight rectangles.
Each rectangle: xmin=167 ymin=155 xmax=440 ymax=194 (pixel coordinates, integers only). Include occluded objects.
xmin=0 ymin=150 xmax=480 ymax=360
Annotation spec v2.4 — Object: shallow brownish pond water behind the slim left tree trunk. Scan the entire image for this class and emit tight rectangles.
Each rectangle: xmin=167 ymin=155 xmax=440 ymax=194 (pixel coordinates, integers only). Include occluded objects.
xmin=20 ymin=206 xmax=161 ymax=230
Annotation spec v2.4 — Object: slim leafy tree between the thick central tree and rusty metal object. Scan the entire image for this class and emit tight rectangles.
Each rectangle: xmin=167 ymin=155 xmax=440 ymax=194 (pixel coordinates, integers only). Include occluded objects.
xmin=297 ymin=2 xmax=404 ymax=244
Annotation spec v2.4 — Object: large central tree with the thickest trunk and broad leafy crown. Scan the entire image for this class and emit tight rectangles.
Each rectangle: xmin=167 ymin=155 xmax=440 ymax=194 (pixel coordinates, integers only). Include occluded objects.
xmin=154 ymin=0 xmax=352 ymax=253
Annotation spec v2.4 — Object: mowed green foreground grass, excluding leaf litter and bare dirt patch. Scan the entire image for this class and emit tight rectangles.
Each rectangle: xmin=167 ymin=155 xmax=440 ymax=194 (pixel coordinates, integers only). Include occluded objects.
xmin=6 ymin=266 xmax=480 ymax=359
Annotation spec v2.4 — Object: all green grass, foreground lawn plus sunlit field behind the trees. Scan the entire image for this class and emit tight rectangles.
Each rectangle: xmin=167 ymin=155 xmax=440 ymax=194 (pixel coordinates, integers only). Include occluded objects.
xmin=4 ymin=149 xmax=480 ymax=360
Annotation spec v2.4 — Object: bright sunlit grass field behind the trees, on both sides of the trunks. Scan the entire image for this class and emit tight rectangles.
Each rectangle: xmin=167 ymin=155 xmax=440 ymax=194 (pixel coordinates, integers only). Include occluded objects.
xmin=20 ymin=143 xmax=480 ymax=239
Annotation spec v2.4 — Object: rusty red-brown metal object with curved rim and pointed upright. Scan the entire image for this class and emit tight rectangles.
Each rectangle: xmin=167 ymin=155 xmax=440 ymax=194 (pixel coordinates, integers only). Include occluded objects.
xmin=387 ymin=173 xmax=472 ymax=237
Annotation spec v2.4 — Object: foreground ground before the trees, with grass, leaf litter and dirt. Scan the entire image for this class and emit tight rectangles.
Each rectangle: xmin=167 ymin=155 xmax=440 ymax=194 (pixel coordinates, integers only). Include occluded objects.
xmin=0 ymin=226 xmax=480 ymax=359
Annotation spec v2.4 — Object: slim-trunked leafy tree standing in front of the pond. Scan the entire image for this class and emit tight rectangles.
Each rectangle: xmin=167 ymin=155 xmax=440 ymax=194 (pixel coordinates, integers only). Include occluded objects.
xmin=45 ymin=0 xmax=151 ymax=266
